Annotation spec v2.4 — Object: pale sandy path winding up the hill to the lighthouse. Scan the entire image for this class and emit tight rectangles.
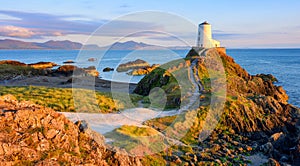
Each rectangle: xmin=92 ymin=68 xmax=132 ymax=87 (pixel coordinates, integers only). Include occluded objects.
xmin=62 ymin=49 xmax=206 ymax=134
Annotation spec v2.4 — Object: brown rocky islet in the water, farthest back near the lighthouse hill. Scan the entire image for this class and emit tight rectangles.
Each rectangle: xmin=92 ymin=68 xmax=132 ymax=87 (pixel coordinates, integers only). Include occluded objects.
xmin=117 ymin=59 xmax=150 ymax=72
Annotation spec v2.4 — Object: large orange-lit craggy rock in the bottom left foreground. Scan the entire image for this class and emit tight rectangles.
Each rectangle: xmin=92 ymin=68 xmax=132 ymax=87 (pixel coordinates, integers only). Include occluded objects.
xmin=0 ymin=95 xmax=141 ymax=166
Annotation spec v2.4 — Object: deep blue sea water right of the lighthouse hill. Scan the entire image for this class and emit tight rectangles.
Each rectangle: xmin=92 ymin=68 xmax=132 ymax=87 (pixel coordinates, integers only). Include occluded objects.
xmin=227 ymin=49 xmax=300 ymax=107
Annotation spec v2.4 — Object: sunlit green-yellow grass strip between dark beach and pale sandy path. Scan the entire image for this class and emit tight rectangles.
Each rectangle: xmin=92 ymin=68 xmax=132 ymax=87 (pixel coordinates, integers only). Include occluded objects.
xmin=0 ymin=86 xmax=141 ymax=113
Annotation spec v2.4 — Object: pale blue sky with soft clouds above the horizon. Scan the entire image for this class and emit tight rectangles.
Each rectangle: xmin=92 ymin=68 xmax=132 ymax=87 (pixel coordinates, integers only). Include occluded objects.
xmin=0 ymin=0 xmax=300 ymax=48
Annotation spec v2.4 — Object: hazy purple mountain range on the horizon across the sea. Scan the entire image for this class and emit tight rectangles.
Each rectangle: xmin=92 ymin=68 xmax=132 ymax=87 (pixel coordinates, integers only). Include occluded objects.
xmin=0 ymin=39 xmax=189 ymax=50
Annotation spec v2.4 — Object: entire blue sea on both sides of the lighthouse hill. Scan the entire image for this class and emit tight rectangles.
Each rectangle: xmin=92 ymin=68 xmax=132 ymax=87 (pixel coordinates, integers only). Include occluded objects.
xmin=0 ymin=49 xmax=300 ymax=107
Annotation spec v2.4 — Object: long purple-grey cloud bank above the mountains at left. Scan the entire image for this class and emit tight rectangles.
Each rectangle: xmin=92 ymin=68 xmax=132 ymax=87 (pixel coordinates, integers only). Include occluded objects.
xmin=0 ymin=10 xmax=163 ymax=39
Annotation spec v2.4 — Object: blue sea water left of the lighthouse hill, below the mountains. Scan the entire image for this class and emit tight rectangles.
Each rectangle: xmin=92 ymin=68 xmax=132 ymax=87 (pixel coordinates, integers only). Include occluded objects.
xmin=0 ymin=50 xmax=188 ymax=83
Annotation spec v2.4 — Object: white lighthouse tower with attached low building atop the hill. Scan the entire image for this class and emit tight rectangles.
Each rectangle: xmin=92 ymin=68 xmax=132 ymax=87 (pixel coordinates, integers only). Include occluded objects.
xmin=197 ymin=21 xmax=220 ymax=48
